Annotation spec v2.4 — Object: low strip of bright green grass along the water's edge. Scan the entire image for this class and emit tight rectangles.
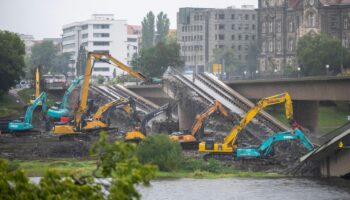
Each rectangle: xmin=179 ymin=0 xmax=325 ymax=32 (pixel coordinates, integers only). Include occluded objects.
xmin=12 ymin=159 xmax=284 ymax=179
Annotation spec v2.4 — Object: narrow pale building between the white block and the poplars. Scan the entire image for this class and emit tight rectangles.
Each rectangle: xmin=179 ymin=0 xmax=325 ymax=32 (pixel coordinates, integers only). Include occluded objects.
xmin=127 ymin=25 xmax=142 ymax=65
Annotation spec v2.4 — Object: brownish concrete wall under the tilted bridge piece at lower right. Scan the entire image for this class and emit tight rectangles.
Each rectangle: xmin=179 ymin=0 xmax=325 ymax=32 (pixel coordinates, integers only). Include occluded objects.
xmin=320 ymin=149 xmax=350 ymax=177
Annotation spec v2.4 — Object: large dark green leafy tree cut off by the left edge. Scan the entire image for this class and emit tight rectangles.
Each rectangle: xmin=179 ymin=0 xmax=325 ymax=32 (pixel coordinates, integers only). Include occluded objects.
xmin=0 ymin=31 xmax=25 ymax=97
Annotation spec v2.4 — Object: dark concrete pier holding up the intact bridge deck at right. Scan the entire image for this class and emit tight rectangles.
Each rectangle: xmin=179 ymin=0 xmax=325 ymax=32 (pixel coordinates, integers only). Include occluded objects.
xmin=293 ymin=100 xmax=319 ymax=133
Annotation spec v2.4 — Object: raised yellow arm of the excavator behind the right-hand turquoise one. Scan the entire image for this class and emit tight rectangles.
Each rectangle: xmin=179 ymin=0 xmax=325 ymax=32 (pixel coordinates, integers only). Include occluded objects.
xmin=224 ymin=92 xmax=293 ymax=147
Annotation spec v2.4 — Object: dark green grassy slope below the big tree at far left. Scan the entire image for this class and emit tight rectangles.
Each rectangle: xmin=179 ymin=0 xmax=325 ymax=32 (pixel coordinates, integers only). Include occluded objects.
xmin=0 ymin=94 xmax=22 ymax=118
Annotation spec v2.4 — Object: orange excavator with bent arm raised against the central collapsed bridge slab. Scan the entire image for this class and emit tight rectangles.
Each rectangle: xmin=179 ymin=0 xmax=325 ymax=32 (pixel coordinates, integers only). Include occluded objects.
xmin=170 ymin=100 xmax=230 ymax=148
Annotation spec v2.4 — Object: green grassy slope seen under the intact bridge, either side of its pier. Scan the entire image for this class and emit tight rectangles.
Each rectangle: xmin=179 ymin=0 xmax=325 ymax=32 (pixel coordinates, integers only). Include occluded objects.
xmin=267 ymin=102 xmax=349 ymax=135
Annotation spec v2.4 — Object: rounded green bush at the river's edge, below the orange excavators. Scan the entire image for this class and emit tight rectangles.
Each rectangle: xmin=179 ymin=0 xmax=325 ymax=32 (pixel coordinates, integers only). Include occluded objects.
xmin=137 ymin=134 xmax=182 ymax=171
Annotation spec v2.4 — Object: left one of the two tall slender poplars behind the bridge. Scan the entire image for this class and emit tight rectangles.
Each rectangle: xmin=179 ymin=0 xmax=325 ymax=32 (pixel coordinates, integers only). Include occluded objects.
xmin=141 ymin=11 xmax=155 ymax=48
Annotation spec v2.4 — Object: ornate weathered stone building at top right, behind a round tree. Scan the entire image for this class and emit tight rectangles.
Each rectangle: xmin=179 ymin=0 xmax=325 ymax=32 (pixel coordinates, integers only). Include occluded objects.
xmin=258 ymin=0 xmax=350 ymax=74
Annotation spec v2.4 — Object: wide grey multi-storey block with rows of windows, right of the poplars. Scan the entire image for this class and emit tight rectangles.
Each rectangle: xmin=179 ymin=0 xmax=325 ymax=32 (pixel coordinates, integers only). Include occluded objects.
xmin=177 ymin=6 xmax=257 ymax=72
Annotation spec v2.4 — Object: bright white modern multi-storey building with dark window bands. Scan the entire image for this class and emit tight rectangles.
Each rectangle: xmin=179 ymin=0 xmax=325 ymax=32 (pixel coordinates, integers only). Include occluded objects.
xmin=62 ymin=14 xmax=127 ymax=79
